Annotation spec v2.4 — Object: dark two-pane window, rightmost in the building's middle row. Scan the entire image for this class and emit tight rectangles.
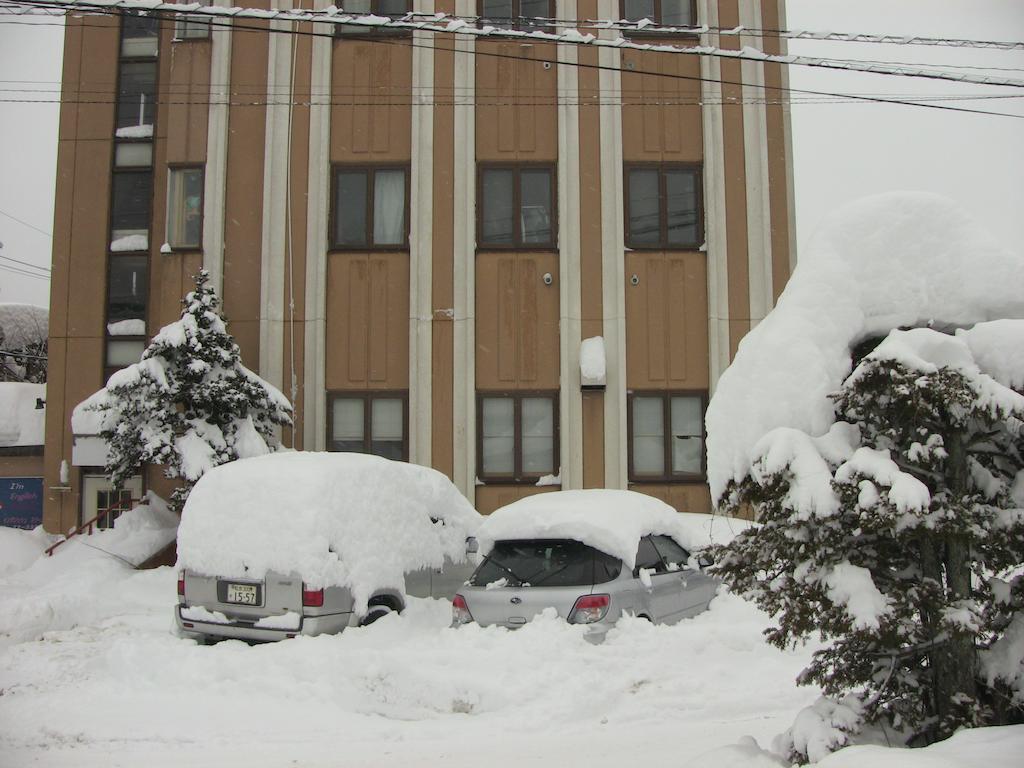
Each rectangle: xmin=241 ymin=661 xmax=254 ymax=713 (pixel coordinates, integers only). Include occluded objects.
xmin=626 ymin=166 xmax=703 ymax=249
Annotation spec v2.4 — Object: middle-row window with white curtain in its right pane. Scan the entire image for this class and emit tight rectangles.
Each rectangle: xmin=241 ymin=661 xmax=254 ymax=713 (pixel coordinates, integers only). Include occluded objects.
xmin=331 ymin=167 xmax=409 ymax=249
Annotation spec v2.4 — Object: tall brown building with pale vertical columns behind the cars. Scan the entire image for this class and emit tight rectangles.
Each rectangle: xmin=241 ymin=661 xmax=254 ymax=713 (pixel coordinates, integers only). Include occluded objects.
xmin=39 ymin=0 xmax=795 ymax=530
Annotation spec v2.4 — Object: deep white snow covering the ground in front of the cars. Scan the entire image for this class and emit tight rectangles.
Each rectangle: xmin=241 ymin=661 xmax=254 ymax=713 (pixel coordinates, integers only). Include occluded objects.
xmin=0 ymin=531 xmax=1024 ymax=768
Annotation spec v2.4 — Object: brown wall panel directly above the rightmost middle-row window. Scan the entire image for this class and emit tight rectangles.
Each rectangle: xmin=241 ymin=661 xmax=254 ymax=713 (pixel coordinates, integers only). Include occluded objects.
xmin=623 ymin=48 xmax=703 ymax=163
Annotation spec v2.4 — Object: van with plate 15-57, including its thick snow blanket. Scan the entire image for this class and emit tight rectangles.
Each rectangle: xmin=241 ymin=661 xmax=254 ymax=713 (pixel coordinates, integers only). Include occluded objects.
xmin=175 ymin=453 xmax=480 ymax=641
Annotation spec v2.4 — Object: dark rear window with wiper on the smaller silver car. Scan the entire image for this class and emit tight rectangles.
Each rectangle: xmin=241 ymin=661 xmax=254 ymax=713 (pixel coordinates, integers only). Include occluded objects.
xmin=469 ymin=539 xmax=623 ymax=587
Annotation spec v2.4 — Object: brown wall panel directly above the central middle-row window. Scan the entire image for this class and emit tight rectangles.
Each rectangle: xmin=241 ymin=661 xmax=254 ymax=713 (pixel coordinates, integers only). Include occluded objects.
xmin=476 ymin=40 xmax=558 ymax=162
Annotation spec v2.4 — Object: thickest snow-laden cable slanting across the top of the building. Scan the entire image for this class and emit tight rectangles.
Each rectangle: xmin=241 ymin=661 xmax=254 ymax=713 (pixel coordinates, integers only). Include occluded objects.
xmin=6 ymin=0 xmax=1024 ymax=88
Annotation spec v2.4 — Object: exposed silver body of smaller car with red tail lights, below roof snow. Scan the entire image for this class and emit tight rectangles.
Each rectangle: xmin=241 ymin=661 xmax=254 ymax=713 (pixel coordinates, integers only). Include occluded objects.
xmin=452 ymin=535 xmax=721 ymax=634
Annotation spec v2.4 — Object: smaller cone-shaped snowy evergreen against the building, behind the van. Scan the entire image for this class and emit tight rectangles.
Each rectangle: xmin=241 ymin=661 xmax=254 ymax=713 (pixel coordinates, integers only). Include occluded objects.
xmin=90 ymin=269 xmax=292 ymax=510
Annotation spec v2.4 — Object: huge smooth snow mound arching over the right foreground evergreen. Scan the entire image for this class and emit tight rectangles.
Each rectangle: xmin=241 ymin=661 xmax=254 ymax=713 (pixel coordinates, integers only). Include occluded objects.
xmin=707 ymin=193 xmax=1024 ymax=502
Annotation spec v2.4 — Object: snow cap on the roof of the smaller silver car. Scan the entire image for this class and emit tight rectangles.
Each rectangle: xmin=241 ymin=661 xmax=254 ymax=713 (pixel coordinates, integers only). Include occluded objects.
xmin=476 ymin=488 xmax=749 ymax=568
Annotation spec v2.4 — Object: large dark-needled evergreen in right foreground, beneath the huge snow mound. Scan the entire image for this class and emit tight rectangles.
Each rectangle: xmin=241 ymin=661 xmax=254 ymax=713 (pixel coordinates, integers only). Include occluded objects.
xmin=717 ymin=329 xmax=1024 ymax=759
